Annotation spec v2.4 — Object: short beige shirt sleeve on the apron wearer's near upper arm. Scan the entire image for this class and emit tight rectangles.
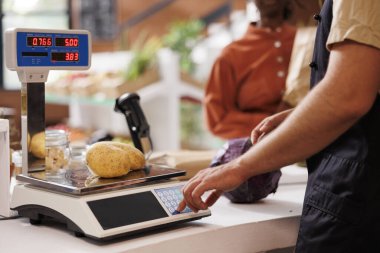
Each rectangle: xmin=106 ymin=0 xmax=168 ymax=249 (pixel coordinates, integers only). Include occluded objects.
xmin=326 ymin=0 xmax=380 ymax=49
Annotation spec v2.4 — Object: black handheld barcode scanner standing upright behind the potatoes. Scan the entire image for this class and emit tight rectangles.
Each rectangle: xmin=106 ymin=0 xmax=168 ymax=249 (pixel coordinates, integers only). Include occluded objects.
xmin=114 ymin=93 xmax=153 ymax=159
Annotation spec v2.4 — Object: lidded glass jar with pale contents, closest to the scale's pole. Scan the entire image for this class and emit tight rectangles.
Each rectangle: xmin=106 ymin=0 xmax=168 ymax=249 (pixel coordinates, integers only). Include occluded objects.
xmin=45 ymin=130 xmax=70 ymax=172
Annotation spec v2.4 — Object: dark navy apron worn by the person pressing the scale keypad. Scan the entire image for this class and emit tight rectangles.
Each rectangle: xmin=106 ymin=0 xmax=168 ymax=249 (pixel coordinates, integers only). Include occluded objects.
xmin=296 ymin=0 xmax=380 ymax=253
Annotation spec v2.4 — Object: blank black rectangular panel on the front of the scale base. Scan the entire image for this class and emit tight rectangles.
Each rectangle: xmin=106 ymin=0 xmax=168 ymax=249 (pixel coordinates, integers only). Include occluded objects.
xmin=87 ymin=192 xmax=168 ymax=230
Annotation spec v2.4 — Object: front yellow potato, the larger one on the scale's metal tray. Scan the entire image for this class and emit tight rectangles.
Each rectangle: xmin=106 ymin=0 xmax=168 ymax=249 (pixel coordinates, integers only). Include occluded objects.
xmin=86 ymin=142 xmax=131 ymax=178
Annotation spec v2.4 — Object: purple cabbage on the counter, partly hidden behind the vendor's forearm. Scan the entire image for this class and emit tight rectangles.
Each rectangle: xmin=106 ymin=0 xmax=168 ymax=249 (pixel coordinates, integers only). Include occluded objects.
xmin=210 ymin=138 xmax=281 ymax=203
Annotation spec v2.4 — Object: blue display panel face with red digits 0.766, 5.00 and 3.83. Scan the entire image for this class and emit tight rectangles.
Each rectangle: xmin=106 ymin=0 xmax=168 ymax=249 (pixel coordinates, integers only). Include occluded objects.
xmin=16 ymin=32 xmax=89 ymax=68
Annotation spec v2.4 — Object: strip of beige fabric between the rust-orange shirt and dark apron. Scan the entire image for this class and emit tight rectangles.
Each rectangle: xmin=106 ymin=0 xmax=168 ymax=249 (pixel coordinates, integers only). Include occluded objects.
xmin=282 ymin=27 xmax=317 ymax=107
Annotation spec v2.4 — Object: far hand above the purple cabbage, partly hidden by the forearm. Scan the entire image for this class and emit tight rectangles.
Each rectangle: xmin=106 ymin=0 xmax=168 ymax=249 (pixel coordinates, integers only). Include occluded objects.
xmin=251 ymin=109 xmax=293 ymax=144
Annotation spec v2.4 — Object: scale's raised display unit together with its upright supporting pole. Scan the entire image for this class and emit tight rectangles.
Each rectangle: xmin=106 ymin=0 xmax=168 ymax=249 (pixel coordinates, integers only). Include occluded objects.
xmin=4 ymin=28 xmax=91 ymax=175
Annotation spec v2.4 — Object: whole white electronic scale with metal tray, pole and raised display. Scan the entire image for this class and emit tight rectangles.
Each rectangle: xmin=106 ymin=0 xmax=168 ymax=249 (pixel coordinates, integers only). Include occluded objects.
xmin=5 ymin=28 xmax=211 ymax=240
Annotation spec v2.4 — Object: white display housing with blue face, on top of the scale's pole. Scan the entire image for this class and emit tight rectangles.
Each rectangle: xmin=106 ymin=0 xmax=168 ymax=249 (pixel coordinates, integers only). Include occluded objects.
xmin=5 ymin=28 xmax=91 ymax=71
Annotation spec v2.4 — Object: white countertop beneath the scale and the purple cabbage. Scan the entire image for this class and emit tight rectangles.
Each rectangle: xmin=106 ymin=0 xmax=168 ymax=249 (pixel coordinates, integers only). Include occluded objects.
xmin=0 ymin=166 xmax=307 ymax=253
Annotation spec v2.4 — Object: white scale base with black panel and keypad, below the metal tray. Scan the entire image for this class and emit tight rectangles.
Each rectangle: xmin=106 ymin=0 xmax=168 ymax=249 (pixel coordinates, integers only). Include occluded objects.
xmin=11 ymin=180 xmax=211 ymax=241
